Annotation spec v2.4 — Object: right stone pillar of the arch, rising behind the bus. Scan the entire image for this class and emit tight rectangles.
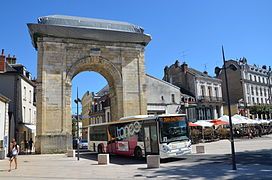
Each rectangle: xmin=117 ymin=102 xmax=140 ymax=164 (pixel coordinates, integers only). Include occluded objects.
xmin=122 ymin=48 xmax=147 ymax=116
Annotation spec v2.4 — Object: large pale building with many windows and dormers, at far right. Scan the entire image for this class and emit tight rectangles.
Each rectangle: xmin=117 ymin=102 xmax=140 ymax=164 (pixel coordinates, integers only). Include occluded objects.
xmin=217 ymin=58 xmax=272 ymax=115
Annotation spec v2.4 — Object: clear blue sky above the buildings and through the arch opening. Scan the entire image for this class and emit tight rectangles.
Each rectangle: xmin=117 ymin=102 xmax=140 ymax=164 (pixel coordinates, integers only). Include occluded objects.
xmin=0 ymin=0 xmax=272 ymax=112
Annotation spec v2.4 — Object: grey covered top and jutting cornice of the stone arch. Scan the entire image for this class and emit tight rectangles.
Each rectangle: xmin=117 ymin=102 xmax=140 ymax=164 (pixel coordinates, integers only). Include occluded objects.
xmin=27 ymin=15 xmax=151 ymax=47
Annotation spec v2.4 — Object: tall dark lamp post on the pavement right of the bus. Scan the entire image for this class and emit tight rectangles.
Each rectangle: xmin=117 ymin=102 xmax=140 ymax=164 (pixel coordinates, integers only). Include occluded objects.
xmin=222 ymin=46 xmax=236 ymax=170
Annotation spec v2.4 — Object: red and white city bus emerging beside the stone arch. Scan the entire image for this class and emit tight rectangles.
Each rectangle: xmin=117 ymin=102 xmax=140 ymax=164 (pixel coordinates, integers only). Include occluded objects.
xmin=88 ymin=114 xmax=192 ymax=159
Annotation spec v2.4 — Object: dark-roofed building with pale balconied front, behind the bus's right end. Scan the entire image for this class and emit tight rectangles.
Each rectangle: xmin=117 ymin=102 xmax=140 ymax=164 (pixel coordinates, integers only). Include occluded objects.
xmin=163 ymin=60 xmax=223 ymax=120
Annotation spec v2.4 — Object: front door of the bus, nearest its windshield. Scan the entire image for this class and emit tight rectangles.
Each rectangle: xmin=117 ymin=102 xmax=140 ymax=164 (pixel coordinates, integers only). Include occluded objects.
xmin=143 ymin=120 xmax=159 ymax=156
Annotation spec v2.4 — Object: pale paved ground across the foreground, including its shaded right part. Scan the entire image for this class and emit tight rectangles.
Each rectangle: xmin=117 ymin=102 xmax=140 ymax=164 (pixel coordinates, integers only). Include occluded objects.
xmin=0 ymin=135 xmax=272 ymax=180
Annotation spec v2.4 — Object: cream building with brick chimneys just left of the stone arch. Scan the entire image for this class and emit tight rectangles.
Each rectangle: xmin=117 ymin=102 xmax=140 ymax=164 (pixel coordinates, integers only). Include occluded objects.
xmin=0 ymin=50 xmax=36 ymax=146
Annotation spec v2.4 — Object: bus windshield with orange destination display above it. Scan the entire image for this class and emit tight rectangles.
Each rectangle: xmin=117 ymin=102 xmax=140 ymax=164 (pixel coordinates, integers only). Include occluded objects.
xmin=159 ymin=116 xmax=189 ymax=143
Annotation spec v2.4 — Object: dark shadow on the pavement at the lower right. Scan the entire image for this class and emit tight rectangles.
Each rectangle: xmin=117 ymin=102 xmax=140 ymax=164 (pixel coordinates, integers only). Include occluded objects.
xmin=142 ymin=150 xmax=272 ymax=180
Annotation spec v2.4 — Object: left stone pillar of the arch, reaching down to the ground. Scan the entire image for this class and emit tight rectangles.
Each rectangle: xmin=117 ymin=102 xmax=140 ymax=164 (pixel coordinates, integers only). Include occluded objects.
xmin=35 ymin=39 xmax=72 ymax=153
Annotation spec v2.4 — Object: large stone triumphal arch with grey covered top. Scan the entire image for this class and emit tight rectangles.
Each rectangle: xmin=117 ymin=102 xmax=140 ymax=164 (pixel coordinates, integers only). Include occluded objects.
xmin=28 ymin=15 xmax=151 ymax=153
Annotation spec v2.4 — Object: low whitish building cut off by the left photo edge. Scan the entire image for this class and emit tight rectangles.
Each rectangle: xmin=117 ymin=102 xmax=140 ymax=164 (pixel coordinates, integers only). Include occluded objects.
xmin=0 ymin=93 xmax=10 ymax=159
